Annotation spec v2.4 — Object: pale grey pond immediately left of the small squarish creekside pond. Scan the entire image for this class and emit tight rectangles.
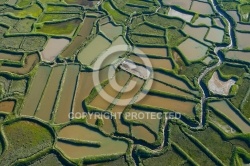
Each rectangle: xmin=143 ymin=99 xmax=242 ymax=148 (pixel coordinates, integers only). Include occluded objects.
xmin=183 ymin=24 xmax=212 ymax=46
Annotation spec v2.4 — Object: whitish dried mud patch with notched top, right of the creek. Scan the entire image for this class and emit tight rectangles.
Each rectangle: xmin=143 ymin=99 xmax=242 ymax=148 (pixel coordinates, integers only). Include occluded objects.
xmin=208 ymin=72 xmax=236 ymax=96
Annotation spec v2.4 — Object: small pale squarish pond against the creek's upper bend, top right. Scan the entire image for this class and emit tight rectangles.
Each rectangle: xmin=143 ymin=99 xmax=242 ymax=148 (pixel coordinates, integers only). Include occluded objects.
xmin=206 ymin=28 xmax=224 ymax=43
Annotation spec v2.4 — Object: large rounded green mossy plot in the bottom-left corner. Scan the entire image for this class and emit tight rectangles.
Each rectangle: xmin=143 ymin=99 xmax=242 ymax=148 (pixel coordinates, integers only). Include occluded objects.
xmin=0 ymin=120 xmax=54 ymax=165
